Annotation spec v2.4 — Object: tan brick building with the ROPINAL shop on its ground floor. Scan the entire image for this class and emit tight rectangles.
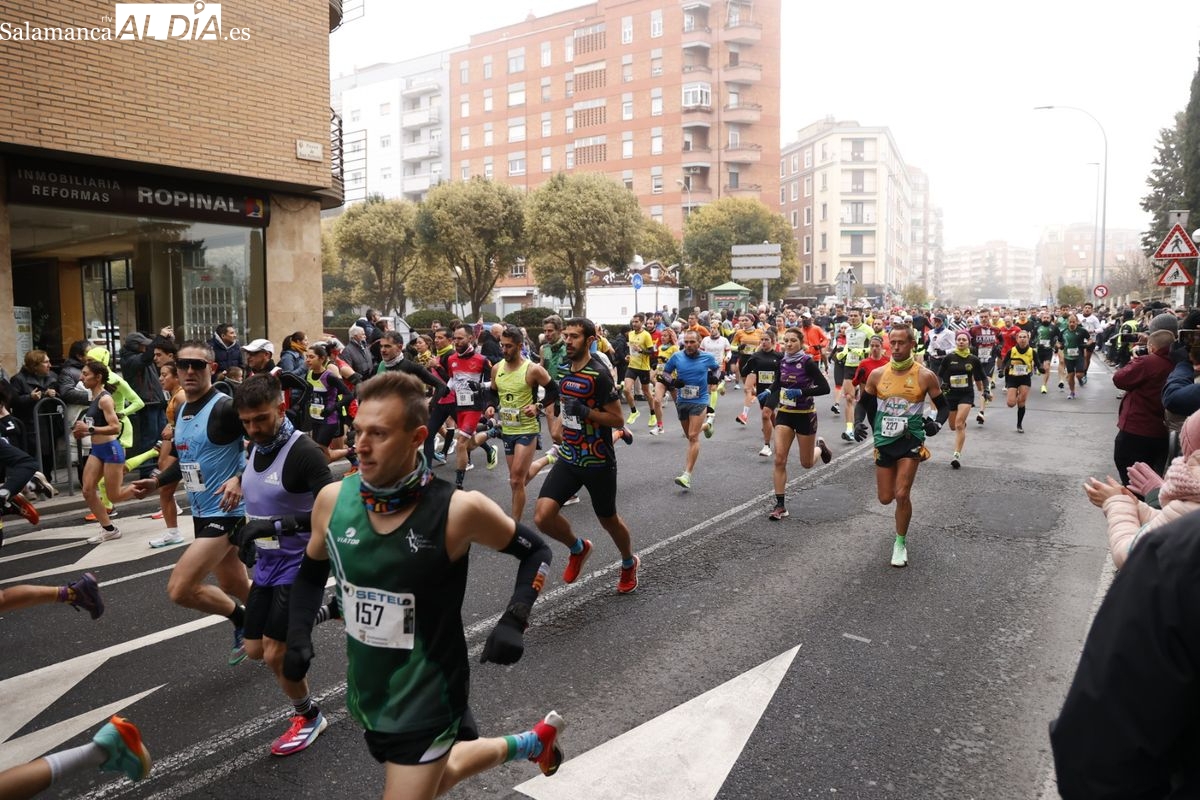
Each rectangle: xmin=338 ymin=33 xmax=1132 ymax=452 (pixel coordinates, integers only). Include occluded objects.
xmin=0 ymin=0 xmax=343 ymax=364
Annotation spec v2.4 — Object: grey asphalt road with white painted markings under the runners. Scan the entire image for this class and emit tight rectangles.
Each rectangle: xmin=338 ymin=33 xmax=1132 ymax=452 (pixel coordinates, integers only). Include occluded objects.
xmin=0 ymin=365 xmax=1117 ymax=800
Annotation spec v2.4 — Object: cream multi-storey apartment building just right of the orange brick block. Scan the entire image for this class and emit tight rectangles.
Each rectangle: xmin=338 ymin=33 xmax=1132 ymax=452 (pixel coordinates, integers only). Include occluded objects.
xmin=779 ymin=118 xmax=919 ymax=302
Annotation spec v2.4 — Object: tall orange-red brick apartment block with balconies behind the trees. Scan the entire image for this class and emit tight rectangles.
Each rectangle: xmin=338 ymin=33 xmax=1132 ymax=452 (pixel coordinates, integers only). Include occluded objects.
xmin=449 ymin=0 xmax=780 ymax=231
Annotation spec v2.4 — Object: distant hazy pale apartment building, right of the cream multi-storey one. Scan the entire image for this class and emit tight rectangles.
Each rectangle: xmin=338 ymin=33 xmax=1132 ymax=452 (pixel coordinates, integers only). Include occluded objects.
xmin=938 ymin=240 xmax=1036 ymax=306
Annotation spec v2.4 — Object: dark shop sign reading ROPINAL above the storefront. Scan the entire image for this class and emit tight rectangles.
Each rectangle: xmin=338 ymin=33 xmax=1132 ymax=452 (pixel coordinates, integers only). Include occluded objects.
xmin=8 ymin=158 xmax=270 ymax=228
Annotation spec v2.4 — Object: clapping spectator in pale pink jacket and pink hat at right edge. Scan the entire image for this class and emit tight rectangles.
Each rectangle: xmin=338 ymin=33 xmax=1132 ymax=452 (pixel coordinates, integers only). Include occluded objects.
xmin=1084 ymin=411 xmax=1200 ymax=570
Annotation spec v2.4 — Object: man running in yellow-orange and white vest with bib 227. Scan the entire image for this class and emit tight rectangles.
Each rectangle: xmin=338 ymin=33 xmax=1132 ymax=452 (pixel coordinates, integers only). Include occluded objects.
xmin=854 ymin=325 xmax=950 ymax=567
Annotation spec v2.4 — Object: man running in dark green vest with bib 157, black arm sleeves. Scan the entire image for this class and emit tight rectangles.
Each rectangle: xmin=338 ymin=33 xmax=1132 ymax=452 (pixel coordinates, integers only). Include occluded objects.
xmin=283 ymin=373 xmax=566 ymax=799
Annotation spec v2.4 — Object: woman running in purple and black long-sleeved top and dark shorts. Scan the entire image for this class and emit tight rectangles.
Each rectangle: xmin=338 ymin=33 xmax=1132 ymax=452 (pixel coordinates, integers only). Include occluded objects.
xmin=760 ymin=327 xmax=833 ymax=522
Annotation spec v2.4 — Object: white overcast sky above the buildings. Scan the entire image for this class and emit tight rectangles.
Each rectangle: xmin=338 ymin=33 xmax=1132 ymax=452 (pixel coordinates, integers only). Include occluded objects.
xmin=330 ymin=0 xmax=1200 ymax=247
